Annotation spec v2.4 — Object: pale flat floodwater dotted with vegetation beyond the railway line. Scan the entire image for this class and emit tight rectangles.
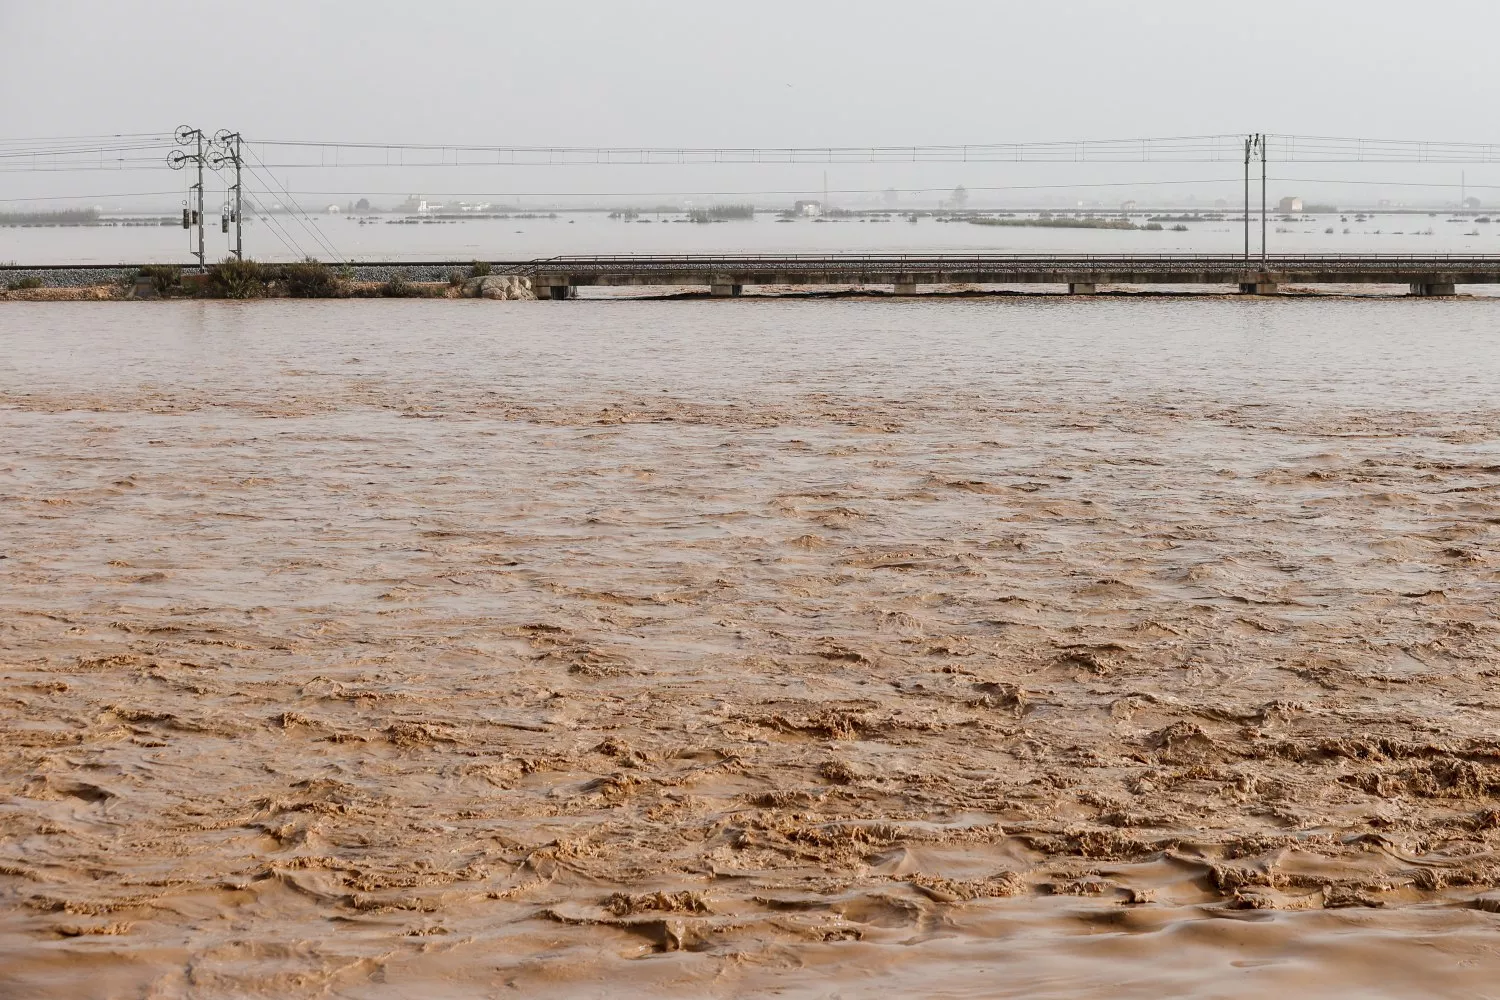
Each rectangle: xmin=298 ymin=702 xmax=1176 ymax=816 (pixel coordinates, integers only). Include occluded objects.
xmin=0 ymin=211 xmax=1500 ymax=264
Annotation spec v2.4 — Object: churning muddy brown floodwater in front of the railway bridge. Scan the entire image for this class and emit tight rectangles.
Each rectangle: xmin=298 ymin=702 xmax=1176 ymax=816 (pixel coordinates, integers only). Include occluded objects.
xmin=0 ymin=298 xmax=1500 ymax=999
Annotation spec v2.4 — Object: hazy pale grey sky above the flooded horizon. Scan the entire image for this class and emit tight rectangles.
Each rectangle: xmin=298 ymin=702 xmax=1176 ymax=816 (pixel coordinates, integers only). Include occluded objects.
xmin=0 ymin=0 xmax=1500 ymax=206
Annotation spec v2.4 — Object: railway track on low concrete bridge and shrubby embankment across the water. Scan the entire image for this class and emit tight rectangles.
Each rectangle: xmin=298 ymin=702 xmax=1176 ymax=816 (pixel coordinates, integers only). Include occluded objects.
xmin=0 ymin=253 xmax=1500 ymax=300
